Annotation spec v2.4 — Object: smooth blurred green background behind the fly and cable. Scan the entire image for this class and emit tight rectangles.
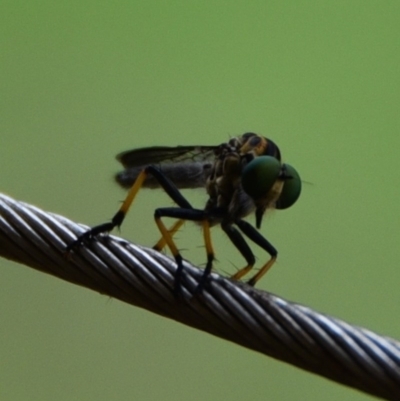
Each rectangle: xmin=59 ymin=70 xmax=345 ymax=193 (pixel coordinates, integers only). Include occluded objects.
xmin=0 ymin=0 xmax=400 ymax=401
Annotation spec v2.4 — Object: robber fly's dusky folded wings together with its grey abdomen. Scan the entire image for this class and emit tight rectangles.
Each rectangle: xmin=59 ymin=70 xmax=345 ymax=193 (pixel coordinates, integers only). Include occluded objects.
xmin=115 ymin=146 xmax=218 ymax=189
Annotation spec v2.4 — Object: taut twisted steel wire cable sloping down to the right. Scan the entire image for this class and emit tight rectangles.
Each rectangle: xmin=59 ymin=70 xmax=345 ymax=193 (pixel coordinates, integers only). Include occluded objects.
xmin=0 ymin=194 xmax=400 ymax=400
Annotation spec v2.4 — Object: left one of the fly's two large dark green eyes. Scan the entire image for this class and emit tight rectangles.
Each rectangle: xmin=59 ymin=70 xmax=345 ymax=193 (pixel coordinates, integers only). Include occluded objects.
xmin=242 ymin=156 xmax=282 ymax=199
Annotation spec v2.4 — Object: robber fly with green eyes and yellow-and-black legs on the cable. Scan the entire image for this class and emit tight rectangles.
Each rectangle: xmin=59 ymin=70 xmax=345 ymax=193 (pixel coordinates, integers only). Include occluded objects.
xmin=67 ymin=133 xmax=301 ymax=292
